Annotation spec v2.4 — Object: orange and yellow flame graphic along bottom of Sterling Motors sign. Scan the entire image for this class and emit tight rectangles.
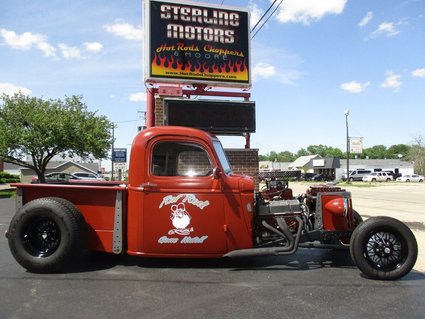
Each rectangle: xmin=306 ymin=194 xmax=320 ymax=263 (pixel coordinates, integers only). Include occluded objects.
xmin=152 ymin=53 xmax=248 ymax=81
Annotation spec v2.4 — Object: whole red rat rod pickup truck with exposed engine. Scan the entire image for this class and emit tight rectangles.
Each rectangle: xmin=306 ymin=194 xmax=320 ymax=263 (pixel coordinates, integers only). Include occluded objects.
xmin=6 ymin=126 xmax=417 ymax=280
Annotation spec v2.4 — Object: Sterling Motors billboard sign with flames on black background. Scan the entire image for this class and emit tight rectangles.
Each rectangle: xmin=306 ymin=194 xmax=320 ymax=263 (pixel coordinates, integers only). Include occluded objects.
xmin=145 ymin=0 xmax=251 ymax=87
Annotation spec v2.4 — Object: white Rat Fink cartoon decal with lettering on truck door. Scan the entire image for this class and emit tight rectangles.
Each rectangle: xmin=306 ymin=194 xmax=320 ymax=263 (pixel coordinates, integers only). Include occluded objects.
xmin=158 ymin=194 xmax=210 ymax=244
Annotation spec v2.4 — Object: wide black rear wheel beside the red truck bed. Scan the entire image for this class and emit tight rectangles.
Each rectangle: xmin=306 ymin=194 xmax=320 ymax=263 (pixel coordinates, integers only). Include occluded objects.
xmin=8 ymin=198 xmax=82 ymax=273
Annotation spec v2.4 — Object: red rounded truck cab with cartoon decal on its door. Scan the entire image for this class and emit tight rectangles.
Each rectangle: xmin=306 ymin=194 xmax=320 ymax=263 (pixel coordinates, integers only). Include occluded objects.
xmin=127 ymin=127 xmax=254 ymax=256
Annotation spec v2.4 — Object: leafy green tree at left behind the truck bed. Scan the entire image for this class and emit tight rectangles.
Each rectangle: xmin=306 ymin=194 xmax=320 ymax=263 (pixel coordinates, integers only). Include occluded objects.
xmin=0 ymin=93 xmax=113 ymax=182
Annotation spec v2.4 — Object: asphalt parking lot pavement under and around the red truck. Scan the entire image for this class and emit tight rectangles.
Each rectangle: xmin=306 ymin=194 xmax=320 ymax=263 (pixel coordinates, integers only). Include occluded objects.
xmin=0 ymin=185 xmax=425 ymax=319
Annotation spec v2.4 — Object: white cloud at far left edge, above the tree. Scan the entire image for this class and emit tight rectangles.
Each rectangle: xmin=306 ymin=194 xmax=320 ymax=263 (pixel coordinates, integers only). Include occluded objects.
xmin=0 ymin=29 xmax=56 ymax=57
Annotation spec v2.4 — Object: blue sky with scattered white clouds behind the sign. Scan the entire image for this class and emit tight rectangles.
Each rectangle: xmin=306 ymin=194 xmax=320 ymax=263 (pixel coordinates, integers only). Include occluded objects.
xmin=0 ymin=0 xmax=425 ymax=168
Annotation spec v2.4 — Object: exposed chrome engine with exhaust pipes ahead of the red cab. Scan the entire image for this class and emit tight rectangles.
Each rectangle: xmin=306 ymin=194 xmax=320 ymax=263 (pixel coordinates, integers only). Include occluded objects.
xmin=254 ymin=177 xmax=349 ymax=250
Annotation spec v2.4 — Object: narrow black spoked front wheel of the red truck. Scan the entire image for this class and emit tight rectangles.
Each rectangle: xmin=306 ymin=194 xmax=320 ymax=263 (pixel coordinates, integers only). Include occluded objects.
xmin=350 ymin=217 xmax=418 ymax=280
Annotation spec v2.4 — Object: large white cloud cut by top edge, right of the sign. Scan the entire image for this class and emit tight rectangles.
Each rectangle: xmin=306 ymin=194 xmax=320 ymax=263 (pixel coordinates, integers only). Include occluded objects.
xmin=277 ymin=0 xmax=347 ymax=24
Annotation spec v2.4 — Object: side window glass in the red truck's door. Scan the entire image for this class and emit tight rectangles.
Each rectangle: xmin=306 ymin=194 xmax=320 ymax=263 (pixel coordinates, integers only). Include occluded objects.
xmin=151 ymin=142 xmax=213 ymax=177
